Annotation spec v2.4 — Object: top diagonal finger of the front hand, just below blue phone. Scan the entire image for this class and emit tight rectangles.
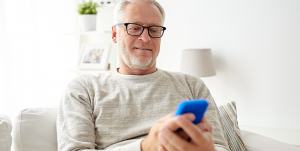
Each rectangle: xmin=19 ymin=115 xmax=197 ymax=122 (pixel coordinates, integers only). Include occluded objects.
xmin=176 ymin=115 xmax=206 ymax=142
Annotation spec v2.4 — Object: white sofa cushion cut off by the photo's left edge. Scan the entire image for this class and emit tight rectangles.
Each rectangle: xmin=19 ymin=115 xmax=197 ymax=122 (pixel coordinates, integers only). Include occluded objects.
xmin=0 ymin=114 xmax=12 ymax=151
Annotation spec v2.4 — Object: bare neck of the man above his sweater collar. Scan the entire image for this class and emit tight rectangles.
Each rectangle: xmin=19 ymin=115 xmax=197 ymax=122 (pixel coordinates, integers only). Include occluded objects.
xmin=117 ymin=64 xmax=157 ymax=75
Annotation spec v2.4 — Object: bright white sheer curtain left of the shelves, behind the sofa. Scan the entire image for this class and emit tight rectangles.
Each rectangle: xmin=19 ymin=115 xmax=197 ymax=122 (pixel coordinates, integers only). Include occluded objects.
xmin=0 ymin=0 xmax=78 ymax=117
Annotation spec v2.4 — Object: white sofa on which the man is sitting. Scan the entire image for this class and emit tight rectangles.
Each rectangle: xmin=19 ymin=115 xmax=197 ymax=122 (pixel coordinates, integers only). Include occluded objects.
xmin=0 ymin=108 xmax=300 ymax=151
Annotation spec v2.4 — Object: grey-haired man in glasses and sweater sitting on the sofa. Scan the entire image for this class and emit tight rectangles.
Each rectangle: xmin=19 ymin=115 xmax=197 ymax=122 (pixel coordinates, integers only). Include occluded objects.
xmin=57 ymin=0 xmax=228 ymax=151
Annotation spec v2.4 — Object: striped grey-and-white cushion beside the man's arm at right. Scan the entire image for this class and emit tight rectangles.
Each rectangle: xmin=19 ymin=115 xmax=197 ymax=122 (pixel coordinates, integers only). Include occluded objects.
xmin=218 ymin=101 xmax=246 ymax=151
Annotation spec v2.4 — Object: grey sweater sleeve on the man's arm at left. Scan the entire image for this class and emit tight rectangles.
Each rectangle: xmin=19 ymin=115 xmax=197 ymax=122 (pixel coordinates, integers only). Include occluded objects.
xmin=56 ymin=77 xmax=141 ymax=151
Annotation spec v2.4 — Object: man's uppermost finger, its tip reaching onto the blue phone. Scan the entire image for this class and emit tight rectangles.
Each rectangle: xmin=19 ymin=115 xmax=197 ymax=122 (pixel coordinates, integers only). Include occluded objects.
xmin=159 ymin=113 xmax=196 ymax=131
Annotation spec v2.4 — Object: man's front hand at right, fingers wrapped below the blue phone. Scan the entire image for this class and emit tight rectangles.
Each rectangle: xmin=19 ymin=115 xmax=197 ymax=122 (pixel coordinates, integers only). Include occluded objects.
xmin=157 ymin=116 xmax=215 ymax=151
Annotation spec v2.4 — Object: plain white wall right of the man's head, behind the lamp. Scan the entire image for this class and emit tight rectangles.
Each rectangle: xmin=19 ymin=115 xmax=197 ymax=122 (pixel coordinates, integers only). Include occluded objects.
xmin=158 ymin=0 xmax=300 ymax=130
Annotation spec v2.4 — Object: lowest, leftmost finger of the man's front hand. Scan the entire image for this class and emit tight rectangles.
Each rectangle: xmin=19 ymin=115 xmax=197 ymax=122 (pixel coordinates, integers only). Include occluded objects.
xmin=158 ymin=129 xmax=191 ymax=151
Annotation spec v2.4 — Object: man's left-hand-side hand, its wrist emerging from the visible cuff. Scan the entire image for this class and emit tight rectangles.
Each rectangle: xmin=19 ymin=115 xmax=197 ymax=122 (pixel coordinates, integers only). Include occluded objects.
xmin=141 ymin=113 xmax=195 ymax=151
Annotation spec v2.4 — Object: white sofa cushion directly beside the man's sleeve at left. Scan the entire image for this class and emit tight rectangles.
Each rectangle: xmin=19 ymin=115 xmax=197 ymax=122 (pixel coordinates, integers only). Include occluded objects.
xmin=13 ymin=108 xmax=58 ymax=151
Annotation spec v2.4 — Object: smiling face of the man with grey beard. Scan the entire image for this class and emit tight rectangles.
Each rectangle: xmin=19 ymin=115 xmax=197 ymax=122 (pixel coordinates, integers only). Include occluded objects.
xmin=113 ymin=2 xmax=162 ymax=70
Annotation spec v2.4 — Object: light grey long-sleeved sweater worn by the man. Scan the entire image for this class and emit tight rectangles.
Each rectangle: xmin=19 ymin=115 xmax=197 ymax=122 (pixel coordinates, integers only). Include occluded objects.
xmin=57 ymin=69 xmax=228 ymax=151
